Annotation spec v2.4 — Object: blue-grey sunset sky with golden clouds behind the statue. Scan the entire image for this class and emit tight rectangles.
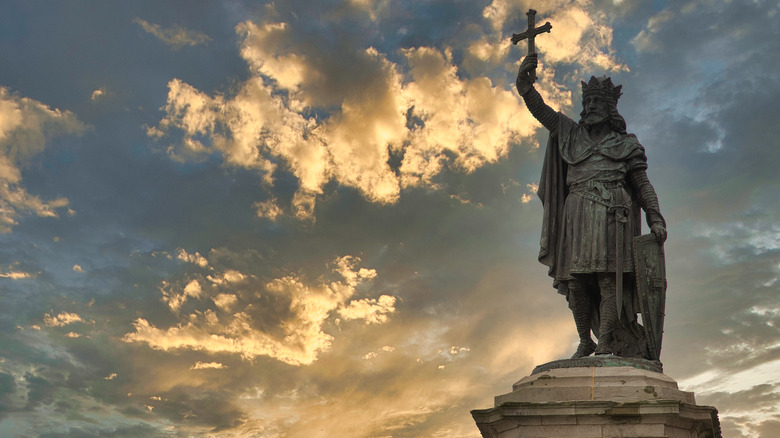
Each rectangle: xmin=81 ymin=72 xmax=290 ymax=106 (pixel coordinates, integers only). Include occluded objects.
xmin=0 ymin=0 xmax=780 ymax=438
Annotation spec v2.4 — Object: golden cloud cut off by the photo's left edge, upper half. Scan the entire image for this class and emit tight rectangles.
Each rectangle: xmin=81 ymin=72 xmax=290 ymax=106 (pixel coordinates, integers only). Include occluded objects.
xmin=0 ymin=87 xmax=86 ymax=233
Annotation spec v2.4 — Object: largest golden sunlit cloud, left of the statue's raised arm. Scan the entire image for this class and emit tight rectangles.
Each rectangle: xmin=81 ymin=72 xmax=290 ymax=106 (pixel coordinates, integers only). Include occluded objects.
xmin=149 ymin=22 xmax=549 ymax=220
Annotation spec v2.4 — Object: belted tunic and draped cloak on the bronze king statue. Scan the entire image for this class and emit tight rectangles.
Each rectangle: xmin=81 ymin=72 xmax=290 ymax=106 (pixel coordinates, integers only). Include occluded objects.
xmin=539 ymin=113 xmax=647 ymax=285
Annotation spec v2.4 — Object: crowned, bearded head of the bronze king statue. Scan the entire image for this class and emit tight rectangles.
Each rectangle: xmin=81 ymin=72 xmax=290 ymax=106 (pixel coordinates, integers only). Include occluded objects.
xmin=580 ymin=76 xmax=626 ymax=134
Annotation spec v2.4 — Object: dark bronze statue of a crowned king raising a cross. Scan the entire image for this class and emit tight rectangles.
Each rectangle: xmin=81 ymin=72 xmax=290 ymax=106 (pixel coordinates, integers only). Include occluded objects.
xmin=512 ymin=10 xmax=667 ymax=360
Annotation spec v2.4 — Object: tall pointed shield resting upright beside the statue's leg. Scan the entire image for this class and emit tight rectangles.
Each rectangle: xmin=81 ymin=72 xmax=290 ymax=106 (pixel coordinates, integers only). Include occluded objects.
xmin=634 ymin=234 xmax=666 ymax=360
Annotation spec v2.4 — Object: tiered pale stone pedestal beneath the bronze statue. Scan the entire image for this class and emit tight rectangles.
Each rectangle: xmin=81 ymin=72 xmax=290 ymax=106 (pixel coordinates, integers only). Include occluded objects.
xmin=471 ymin=356 xmax=721 ymax=438
